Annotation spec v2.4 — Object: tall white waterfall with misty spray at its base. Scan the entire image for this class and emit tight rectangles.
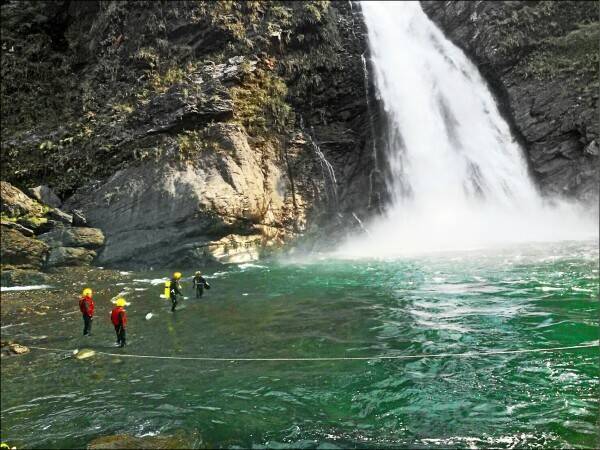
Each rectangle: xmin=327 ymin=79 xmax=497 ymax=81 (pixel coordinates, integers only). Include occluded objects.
xmin=340 ymin=1 xmax=598 ymax=256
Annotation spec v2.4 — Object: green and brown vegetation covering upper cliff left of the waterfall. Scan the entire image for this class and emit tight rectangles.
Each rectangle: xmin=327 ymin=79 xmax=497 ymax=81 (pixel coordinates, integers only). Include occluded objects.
xmin=1 ymin=1 xmax=352 ymax=195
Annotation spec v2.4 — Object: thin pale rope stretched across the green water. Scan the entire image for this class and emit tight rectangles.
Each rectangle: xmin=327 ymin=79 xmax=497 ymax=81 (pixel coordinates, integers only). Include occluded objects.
xmin=29 ymin=343 xmax=598 ymax=362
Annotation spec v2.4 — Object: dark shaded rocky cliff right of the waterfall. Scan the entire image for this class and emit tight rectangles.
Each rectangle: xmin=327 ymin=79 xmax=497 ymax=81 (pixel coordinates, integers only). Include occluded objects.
xmin=422 ymin=1 xmax=600 ymax=208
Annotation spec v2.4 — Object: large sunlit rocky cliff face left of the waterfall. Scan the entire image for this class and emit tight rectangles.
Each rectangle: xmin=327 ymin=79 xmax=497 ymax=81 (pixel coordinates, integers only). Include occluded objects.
xmin=1 ymin=1 xmax=379 ymax=265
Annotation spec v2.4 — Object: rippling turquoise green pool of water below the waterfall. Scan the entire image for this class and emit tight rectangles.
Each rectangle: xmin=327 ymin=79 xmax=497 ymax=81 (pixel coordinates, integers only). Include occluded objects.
xmin=1 ymin=242 xmax=600 ymax=448
